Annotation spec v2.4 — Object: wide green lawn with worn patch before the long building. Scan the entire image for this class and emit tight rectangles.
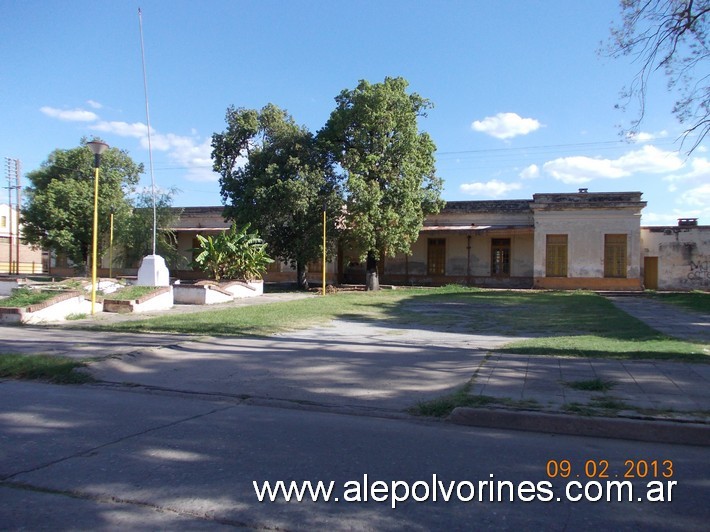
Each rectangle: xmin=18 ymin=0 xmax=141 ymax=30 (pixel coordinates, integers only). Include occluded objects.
xmin=92 ymin=286 xmax=710 ymax=362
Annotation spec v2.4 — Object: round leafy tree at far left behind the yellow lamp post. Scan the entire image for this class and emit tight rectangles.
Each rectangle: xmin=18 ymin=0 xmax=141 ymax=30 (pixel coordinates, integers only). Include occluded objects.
xmin=22 ymin=139 xmax=143 ymax=269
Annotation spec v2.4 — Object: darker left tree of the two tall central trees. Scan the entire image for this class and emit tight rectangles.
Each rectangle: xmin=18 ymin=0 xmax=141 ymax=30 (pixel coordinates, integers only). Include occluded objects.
xmin=212 ymin=104 xmax=341 ymax=289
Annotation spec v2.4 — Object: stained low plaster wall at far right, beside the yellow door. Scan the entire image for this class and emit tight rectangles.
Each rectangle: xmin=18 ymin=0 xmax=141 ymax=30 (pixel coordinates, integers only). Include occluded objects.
xmin=641 ymin=226 xmax=710 ymax=290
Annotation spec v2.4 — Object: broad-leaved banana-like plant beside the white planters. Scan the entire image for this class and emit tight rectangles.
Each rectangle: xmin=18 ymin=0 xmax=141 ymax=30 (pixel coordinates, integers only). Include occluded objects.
xmin=195 ymin=224 xmax=274 ymax=281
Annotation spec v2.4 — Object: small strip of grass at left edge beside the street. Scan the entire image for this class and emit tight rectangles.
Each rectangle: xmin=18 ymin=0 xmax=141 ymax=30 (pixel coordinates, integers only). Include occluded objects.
xmin=0 ymin=354 xmax=93 ymax=384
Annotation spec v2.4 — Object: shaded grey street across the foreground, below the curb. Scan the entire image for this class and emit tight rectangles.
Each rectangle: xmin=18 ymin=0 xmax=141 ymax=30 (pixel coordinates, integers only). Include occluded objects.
xmin=0 ymin=381 xmax=710 ymax=531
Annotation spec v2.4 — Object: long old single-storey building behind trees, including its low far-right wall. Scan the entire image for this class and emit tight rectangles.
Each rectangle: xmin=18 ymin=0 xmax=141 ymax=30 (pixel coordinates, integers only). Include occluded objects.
xmin=67 ymin=189 xmax=710 ymax=291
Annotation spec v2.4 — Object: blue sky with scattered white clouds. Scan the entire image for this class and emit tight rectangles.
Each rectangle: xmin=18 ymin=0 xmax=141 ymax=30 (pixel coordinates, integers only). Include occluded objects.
xmin=0 ymin=0 xmax=710 ymax=225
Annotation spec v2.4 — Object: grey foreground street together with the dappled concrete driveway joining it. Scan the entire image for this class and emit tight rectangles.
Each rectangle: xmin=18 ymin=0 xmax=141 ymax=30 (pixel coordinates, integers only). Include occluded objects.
xmin=0 ymin=323 xmax=710 ymax=531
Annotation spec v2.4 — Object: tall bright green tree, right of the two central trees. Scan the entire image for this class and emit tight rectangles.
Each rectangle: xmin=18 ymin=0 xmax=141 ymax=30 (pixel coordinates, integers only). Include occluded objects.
xmin=319 ymin=77 xmax=444 ymax=290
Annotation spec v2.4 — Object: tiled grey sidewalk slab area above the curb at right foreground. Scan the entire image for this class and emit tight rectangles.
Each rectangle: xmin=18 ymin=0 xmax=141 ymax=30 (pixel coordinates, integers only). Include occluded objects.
xmin=472 ymin=354 xmax=710 ymax=422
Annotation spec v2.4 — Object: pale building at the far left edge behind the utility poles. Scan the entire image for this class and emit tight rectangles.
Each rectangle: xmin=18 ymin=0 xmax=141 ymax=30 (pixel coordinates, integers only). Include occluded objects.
xmin=0 ymin=203 xmax=44 ymax=275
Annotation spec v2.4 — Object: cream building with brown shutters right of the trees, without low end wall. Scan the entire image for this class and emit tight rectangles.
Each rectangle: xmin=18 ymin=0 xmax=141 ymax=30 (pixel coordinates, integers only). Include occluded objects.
xmin=346 ymin=189 xmax=646 ymax=290
